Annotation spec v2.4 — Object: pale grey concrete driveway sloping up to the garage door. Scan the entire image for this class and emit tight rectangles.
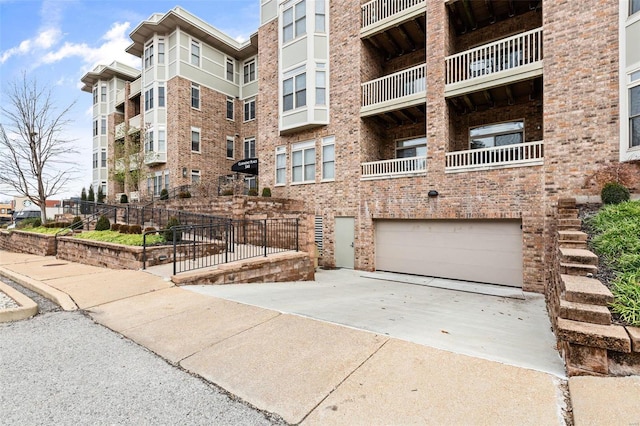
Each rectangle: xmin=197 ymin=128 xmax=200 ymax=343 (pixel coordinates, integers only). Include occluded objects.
xmin=184 ymin=269 xmax=565 ymax=377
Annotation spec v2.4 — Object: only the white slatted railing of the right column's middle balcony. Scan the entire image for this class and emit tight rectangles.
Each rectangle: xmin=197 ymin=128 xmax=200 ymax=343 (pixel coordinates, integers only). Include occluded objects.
xmin=445 ymin=28 xmax=542 ymax=84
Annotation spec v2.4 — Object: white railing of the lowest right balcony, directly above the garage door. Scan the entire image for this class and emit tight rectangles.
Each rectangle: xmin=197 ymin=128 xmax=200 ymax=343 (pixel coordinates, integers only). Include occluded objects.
xmin=445 ymin=141 xmax=544 ymax=172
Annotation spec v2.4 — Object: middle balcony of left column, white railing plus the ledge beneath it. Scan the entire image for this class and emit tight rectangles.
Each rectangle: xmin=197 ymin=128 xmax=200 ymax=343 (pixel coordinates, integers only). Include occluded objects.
xmin=360 ymin=64 xmax=427 ymax=117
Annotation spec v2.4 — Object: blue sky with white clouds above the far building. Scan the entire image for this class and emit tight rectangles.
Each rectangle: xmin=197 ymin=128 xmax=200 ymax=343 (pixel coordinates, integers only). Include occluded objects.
xmin=0 ymin=0 xmax=260 ymax=200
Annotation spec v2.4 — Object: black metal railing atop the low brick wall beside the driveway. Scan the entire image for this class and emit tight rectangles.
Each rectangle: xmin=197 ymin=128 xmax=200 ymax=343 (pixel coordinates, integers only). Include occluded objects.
xmin=166 ymin=219 xmax=299 ymax=275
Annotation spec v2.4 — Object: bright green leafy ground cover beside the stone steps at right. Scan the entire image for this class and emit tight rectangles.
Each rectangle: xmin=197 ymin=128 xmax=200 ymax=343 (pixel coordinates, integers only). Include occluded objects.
xmin=587 ymin=201 xmax=640 ymax=326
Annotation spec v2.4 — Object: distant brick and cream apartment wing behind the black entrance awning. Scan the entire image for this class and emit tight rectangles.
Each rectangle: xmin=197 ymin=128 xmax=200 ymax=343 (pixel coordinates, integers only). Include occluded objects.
xmin=82 ymin=7 xmax=258 ymax=199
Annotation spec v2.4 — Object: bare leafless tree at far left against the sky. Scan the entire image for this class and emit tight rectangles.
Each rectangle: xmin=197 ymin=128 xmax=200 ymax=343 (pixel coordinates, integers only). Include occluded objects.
xmin=0 ymin=74 xmax=78 ymax=223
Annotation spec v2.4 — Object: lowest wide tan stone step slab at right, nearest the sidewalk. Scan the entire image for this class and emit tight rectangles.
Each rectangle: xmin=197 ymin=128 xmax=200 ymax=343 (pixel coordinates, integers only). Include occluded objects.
xmin=557 ymin=318 xmax=631 ymax=353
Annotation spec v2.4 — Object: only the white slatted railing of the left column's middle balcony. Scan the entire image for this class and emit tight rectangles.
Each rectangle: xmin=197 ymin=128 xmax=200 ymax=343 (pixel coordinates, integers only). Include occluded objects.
xmin=362 ymin=64 xmax=427 ymax=107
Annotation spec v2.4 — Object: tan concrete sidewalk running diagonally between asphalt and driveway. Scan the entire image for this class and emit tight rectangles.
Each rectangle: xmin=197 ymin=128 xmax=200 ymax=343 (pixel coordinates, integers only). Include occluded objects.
xmin=0 ymin=251 xmax=640 ymax=425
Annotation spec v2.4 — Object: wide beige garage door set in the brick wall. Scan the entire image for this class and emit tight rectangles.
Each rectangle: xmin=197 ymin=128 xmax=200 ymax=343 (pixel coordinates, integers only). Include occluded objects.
xmin=375 ymin=220 xmax=522 ymax=287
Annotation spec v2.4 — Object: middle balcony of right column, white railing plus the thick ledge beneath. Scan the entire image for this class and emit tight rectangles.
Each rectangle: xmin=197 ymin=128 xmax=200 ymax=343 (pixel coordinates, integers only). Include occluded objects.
xmin=445 ymin=28 xmax=543 ymax=97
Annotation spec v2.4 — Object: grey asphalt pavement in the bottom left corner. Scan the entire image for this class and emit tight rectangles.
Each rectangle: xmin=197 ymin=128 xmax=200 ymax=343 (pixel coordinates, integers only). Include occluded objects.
xmin=0 ymin=311 xmax=284 ymax=425
